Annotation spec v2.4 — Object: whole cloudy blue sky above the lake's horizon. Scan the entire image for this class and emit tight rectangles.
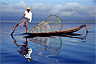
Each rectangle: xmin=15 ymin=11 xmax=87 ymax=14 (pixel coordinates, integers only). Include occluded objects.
xmin=0 ymin=0 xmax=96 ymax=21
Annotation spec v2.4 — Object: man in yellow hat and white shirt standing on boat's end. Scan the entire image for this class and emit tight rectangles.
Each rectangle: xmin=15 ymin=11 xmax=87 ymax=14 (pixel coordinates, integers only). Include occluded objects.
xmin=11 ymin=7 xmax=32 ymax=35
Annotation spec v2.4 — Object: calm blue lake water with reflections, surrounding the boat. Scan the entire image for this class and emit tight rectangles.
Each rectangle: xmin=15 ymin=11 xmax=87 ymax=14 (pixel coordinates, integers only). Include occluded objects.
xmin=0 ymin=22 xmax=96 ymax=64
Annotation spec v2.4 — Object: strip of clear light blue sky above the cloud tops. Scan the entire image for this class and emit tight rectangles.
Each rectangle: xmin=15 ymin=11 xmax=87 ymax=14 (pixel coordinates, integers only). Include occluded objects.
xmin=1 ymin=0 xmax=95 ymax=5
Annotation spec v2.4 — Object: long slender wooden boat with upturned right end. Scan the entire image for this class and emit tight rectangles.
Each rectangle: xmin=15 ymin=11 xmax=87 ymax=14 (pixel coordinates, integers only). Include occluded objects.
xmin=24 ymin=24 xmax=88 ymax=36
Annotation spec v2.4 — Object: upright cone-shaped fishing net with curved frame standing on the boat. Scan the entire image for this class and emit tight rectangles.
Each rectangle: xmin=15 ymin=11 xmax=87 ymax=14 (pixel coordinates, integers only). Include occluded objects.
xmin=29 ymin=15 xmax=62 ymax=33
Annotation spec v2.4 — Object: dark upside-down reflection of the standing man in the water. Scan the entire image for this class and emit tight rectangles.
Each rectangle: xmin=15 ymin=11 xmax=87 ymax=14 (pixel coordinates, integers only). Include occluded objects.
xmin=11 ymin=35 xmax=32 ymax=61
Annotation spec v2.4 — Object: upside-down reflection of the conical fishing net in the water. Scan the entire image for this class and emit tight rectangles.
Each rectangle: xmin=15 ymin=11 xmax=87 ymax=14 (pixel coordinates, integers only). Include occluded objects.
xmin=30 ymin=37 xmax=62 ymax=52
